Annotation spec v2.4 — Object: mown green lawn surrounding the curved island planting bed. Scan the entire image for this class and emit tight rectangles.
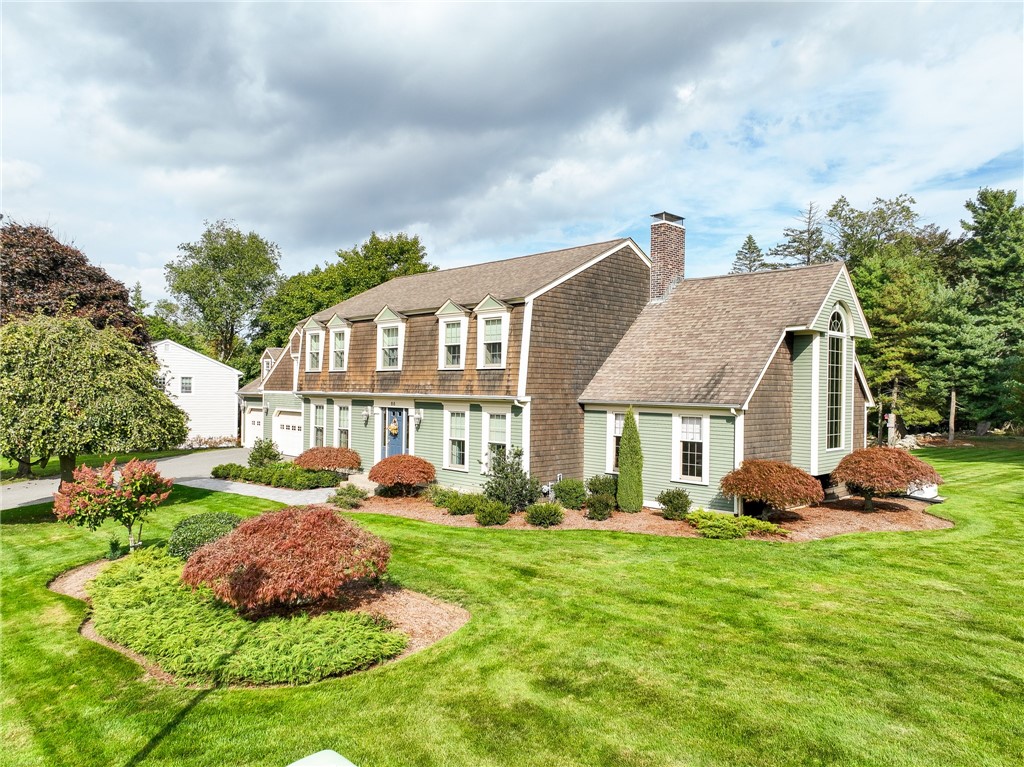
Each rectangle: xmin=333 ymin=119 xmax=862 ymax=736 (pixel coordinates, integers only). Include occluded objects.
xmin=0 ymin=449 xmax=1024 ymax=767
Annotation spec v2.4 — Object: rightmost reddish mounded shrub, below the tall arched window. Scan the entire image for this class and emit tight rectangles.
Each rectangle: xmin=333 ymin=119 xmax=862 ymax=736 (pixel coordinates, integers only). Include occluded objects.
xmin=831 ymin=446 xmax=942 ymax=511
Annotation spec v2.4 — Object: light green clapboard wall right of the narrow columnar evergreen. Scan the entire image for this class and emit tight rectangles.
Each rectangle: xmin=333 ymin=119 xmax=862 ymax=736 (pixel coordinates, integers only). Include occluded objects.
xmin=637 ymin=411 xmax=735 ymax=512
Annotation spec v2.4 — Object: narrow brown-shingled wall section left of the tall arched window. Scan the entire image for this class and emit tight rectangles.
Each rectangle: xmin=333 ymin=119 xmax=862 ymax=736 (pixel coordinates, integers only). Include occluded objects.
xmin=743 ymin=333 xmax=793 ymax=462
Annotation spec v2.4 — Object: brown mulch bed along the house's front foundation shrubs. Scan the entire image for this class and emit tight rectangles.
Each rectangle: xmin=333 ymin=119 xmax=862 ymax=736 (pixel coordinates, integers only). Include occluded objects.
xmin=354 ymin=496 xmax=953 ymax=542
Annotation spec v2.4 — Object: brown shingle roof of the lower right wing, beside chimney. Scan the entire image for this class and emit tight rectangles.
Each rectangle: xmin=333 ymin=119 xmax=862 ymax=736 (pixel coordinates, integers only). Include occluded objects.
xmin=580 ymin=262 xmax=867 ymax=408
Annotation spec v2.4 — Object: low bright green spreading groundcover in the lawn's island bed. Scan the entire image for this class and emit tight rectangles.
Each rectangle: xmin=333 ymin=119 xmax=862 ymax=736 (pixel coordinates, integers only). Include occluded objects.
xmin=88 ymin=548 xmax=407 ymax=684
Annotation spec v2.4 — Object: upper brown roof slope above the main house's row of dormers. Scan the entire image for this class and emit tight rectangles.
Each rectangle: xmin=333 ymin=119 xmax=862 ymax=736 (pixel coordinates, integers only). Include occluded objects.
xmin=313 ymin=239 xmax=629 ymax=315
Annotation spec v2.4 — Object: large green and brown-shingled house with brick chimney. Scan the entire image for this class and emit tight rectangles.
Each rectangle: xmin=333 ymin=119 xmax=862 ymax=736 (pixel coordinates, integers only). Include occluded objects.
xmin=240 ymin=213 xmax=872 ymax=511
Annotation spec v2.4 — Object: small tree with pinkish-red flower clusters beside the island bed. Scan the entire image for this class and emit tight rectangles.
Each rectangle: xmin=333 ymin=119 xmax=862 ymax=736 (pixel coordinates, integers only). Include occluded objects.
xmin=53 ymin=459 xmax=174 ymax=549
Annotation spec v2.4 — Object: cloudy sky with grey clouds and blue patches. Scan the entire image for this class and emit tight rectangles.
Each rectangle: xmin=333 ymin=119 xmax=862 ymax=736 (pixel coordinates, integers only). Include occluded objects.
xmin=0 ymin=1 xmax=1024 ymax=298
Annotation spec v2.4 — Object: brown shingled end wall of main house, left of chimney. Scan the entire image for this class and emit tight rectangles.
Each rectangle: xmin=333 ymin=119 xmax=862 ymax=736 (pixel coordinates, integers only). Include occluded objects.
xmin=528 ymin=248 xmax=650 ymax=481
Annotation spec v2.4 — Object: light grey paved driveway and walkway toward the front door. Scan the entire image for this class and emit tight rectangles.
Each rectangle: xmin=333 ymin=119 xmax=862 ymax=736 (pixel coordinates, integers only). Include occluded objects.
xmin=0 ymin=448 xmax=374 ymax=509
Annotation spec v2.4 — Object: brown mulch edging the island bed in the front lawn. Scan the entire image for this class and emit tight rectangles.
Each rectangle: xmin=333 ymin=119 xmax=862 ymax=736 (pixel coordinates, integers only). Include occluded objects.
xmin=47 ymin=559 xmax=471 ymax=688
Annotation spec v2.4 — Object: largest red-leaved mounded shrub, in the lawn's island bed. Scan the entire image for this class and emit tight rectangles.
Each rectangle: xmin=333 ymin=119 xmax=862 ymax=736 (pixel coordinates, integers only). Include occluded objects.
xmin=181 ymin=505 xmax=391 ymax=612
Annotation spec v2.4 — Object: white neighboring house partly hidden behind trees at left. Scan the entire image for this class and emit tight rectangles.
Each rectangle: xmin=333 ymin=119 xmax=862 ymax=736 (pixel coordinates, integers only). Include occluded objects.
xmin=153 ymin=339 xmax=242 ymax=439
